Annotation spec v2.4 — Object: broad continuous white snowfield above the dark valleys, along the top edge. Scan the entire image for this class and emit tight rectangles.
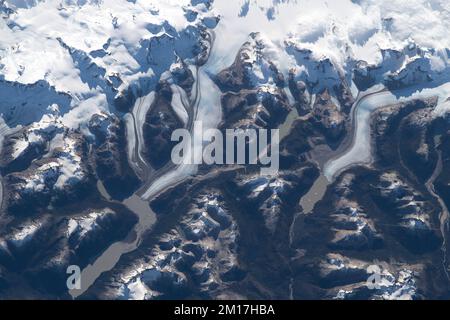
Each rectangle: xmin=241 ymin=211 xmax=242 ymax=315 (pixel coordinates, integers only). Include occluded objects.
xmin=0 ymin=0 xmax=450 ymax=155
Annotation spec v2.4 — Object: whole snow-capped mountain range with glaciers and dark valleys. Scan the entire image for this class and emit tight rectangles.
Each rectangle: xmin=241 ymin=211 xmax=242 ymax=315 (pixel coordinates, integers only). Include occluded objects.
xmin=0 ymin=0 xmax=450 ymax=299
